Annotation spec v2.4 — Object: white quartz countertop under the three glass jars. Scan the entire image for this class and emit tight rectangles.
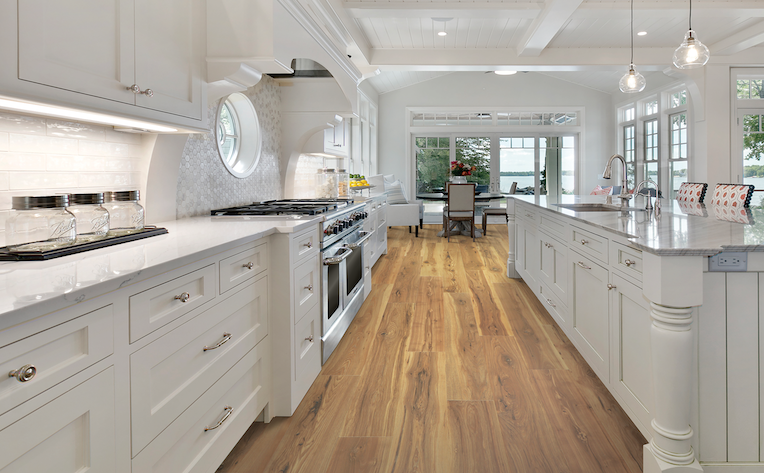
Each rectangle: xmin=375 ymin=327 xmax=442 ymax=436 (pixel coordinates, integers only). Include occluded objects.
xmin=0 ymin=216 xmax=323 ymax=318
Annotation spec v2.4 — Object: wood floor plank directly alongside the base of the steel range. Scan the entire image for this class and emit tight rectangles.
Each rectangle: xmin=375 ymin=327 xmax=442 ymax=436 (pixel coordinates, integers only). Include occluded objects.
xmin=321 ymin=284 xmax=392 ymax=376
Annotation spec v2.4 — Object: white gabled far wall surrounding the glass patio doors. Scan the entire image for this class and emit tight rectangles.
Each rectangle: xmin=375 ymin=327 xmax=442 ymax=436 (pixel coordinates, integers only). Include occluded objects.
xmin=379 ymin=72 xmax=616 ymax=192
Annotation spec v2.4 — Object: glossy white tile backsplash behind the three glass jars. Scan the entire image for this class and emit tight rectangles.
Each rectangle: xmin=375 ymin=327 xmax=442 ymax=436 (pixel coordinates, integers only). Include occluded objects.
xmin=0 ymin=112 xmax=148 ymax=246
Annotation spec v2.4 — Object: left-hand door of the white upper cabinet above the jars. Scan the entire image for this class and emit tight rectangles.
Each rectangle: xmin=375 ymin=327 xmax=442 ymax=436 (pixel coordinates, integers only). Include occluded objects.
xmin=18 ymin=0 xmax=135 ymax=104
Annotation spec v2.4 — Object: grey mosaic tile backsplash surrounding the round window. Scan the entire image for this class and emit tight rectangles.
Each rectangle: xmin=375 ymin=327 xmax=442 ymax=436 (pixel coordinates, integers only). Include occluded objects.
xmin=177 ymin=75 xmax=283 ymax=218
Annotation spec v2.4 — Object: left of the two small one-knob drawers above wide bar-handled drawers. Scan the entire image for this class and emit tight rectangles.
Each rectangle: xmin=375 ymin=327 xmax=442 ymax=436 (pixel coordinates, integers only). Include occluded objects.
xmin=130 ymin=264 xmax=215 ymax=343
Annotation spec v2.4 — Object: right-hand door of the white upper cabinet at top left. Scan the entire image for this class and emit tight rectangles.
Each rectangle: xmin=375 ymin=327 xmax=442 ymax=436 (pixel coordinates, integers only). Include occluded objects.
xmin=135 ymin=0 xmax=205 ymax=119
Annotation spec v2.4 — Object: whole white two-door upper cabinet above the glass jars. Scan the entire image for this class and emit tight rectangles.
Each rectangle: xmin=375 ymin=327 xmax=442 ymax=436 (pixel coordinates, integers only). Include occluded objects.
xmin=0 ymin=0 xmax=207 ymax=129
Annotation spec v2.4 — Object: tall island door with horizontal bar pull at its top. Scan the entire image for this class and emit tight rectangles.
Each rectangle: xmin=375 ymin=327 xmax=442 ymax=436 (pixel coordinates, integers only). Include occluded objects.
xmin=568 ymin=250 xmax=610 ymax=384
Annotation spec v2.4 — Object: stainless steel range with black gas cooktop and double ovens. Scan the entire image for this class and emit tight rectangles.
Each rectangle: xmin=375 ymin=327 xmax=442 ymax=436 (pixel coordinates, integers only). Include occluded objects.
xmin=212 ymin=199 xmax=373 ymax=363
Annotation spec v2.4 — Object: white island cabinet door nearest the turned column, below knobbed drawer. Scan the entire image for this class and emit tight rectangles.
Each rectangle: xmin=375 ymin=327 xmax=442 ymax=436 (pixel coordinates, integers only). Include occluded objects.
xmin=610 ymin=274 xmax=653 ymax=430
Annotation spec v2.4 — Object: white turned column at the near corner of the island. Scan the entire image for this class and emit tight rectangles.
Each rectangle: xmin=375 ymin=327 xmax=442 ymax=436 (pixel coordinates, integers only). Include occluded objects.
xmin=642 ymin=252 xmax=703 ymax=473
